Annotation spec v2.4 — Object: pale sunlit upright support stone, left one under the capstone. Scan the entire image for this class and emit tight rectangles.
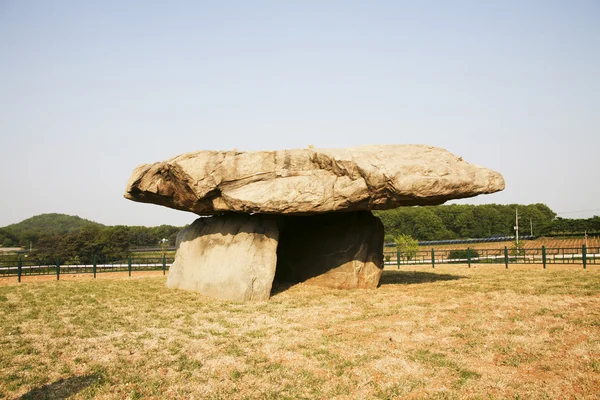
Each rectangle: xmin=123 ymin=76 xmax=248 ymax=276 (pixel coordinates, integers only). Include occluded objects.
xmin=167 ymin=214 xmax=279 ymax=301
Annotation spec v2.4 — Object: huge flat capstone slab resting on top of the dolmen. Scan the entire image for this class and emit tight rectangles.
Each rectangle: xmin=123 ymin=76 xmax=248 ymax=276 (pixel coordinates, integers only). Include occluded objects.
xmin=125 ymin=145 xmax=504 ymax=215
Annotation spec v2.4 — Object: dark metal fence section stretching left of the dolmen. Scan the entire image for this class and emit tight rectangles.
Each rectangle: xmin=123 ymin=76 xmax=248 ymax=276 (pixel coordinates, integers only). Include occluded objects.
xmin=0 ymin=256 xmax=173 ymax=282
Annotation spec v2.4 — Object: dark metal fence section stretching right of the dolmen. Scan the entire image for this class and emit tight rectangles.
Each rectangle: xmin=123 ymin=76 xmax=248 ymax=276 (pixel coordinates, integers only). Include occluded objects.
xmin=383 ymin=245 xmax=600 ymax=268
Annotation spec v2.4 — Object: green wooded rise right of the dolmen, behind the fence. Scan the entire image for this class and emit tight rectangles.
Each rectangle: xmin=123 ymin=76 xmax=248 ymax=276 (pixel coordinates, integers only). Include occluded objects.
xmin=375 ymin=204 xmax=600 ymax=241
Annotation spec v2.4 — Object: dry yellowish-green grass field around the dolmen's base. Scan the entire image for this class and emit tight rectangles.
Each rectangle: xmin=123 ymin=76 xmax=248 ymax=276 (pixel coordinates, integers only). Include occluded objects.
xmin=0 ymin=265 xmax=600 ymax=399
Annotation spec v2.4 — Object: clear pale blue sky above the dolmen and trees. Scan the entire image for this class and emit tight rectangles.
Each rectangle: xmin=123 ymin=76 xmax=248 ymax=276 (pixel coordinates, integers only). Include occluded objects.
xmin=0 ymin=0 xmax=600 ymax=226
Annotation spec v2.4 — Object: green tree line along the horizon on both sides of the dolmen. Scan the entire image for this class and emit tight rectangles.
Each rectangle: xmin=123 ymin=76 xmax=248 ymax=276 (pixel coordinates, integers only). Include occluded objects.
xmin=0 ymin=204 xmax=600 ymax=263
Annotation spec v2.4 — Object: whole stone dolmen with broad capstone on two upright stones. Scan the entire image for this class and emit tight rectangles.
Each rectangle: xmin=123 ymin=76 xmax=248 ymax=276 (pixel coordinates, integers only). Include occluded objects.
xmin=125 ymin=145 xmax=504 ymax=301
